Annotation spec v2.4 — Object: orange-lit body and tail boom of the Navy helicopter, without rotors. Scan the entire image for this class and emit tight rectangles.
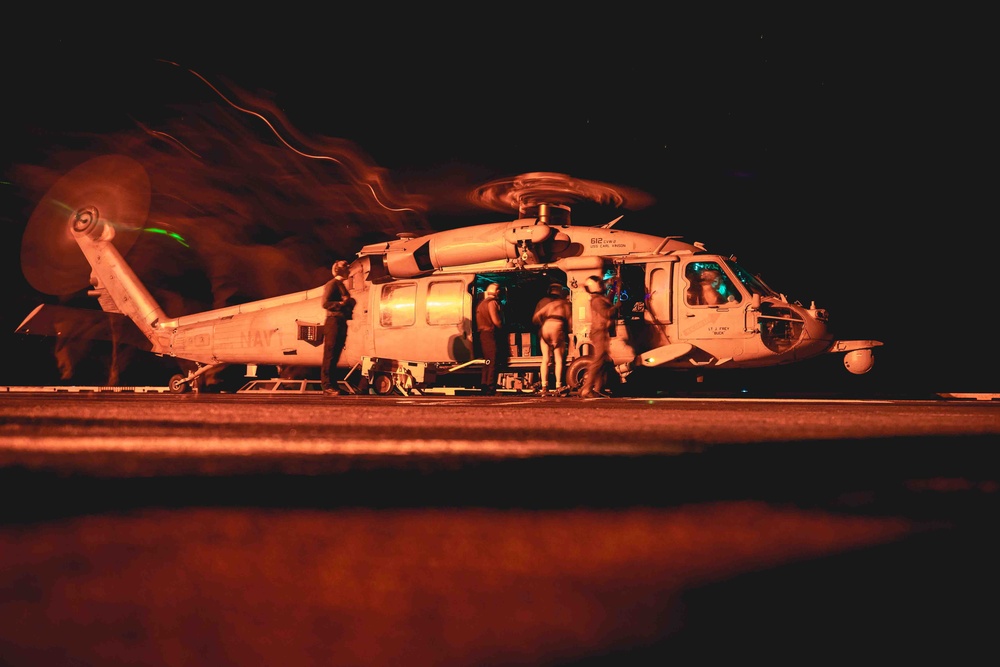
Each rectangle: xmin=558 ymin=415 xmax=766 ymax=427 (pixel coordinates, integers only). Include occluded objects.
xmin=56 ymin=214 xmax=878 ymax=389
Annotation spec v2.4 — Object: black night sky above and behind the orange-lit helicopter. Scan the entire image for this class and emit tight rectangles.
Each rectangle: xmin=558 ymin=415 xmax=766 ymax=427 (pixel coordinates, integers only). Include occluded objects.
xmin=0 ymin=15 xmax=1000 ymax=391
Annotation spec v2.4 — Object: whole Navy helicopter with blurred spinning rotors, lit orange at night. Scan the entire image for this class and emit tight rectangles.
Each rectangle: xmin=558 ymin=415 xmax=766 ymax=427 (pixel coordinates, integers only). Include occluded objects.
xmin=17 ymin=154 xmax=882 ymax=395
